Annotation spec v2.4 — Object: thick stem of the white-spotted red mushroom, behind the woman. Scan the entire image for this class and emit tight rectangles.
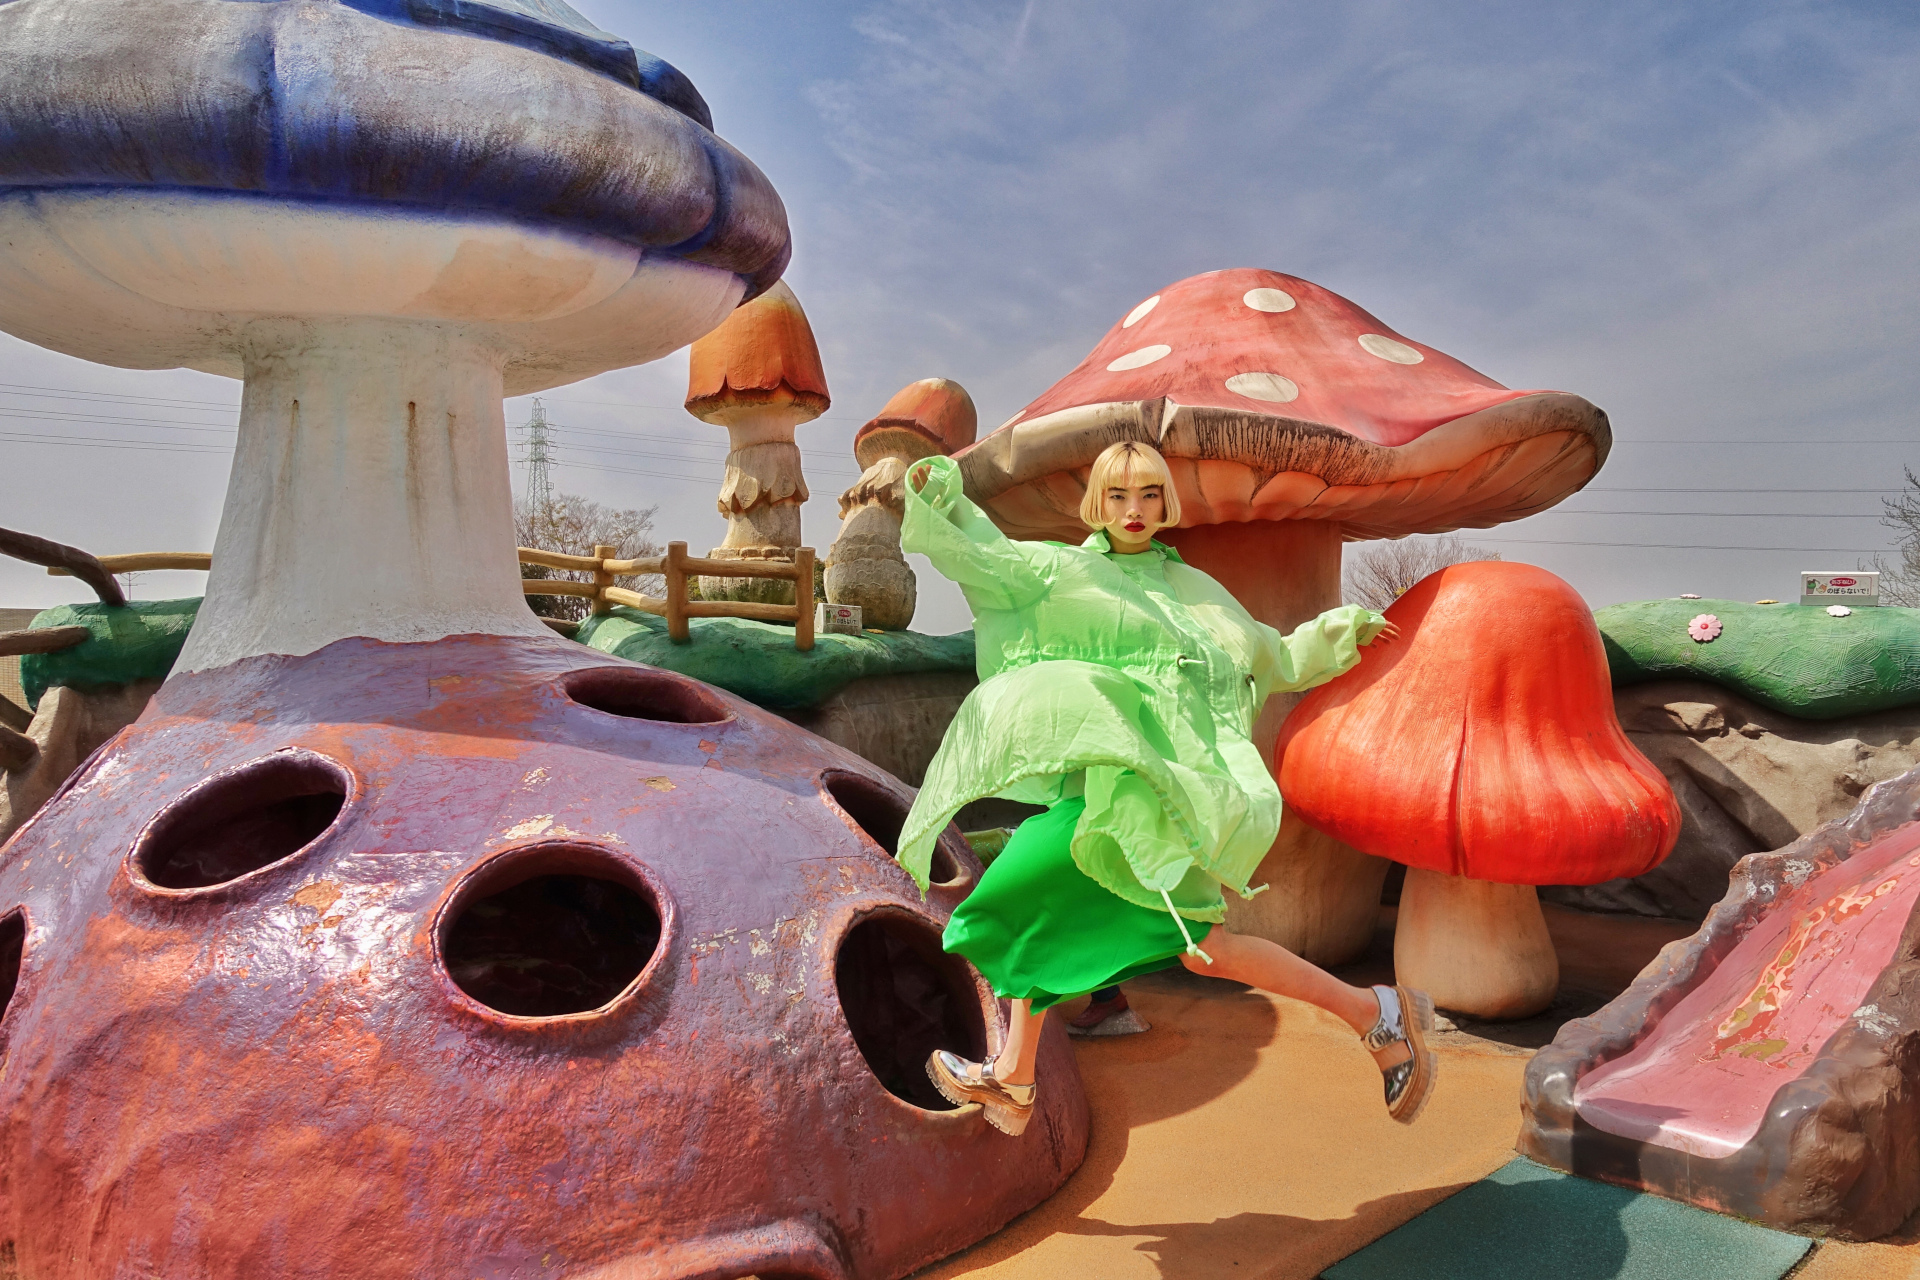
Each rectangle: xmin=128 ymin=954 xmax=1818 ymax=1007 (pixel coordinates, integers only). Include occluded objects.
xmin=1162 ymin=520 xmax=1390 ymax=965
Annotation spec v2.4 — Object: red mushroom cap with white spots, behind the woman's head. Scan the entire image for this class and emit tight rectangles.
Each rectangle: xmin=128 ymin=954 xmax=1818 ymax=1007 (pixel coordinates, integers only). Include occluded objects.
xmin=958 ymin=269 xmax=1611 ymax=541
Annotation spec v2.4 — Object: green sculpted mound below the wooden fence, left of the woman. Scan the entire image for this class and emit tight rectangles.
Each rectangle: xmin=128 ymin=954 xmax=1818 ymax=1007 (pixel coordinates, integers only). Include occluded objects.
xmin=574 ymin=608 xmax=973 ymax=710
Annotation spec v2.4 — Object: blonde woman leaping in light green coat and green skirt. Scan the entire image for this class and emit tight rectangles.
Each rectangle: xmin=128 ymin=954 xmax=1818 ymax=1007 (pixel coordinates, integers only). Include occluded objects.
xmin=900 ymin=441 xmax=1436 ymax=1134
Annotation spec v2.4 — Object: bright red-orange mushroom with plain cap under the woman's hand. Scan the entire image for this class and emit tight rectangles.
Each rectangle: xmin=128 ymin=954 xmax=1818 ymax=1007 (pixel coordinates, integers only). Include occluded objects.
xmin=1277 ymin=560 xmax=1680 ymax=1017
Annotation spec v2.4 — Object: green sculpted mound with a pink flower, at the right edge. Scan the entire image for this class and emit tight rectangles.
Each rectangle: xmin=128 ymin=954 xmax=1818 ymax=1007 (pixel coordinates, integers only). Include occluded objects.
xmin=1594 ymin=601 xmax=1920 ymax=720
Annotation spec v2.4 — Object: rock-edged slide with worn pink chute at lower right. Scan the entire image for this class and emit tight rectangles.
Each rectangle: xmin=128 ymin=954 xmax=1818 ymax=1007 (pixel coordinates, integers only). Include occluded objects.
xmin=1519 ymin=770 xmax=1920 ymax=1240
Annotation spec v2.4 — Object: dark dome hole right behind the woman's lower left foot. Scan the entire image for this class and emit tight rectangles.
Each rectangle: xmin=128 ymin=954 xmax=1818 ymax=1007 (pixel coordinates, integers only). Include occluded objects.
xmin=833 ymin=912 xmax=987 ymax=1111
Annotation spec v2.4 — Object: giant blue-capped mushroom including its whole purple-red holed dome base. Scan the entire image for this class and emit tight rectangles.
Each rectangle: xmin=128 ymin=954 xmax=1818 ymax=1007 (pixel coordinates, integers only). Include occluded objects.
xmin=0 ymin=0 xmax=1087 ymax=1280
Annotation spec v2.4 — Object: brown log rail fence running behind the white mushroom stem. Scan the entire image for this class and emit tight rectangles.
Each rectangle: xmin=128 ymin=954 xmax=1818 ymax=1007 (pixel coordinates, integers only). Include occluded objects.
xmin=46 ymin=543 xmax=814 ymax=651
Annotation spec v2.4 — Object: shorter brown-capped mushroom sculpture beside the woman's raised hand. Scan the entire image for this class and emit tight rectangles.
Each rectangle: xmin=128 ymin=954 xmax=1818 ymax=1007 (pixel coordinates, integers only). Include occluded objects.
xmin=826 ymin=378 xmax=979 ymax=631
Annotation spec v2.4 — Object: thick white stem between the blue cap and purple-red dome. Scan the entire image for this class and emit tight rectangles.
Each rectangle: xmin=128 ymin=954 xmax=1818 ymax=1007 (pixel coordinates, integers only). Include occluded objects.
xmin=175 ymin=319 xmax=547 ymax=672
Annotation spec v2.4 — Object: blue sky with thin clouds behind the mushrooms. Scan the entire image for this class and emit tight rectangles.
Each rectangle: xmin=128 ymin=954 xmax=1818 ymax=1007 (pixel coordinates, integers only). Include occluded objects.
xmin=0 ymin=0 xmax=1920 ymax=629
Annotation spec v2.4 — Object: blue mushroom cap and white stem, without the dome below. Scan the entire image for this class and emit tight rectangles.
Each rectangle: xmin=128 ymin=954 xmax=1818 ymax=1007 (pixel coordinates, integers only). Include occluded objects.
xmin=0 ymin=0 xmax=789 ymax=670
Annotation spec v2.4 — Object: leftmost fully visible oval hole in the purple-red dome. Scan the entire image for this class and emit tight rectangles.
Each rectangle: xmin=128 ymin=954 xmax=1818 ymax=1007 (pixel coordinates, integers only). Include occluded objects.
xmin=134 ymin=750 xmax=348 ymax=889
